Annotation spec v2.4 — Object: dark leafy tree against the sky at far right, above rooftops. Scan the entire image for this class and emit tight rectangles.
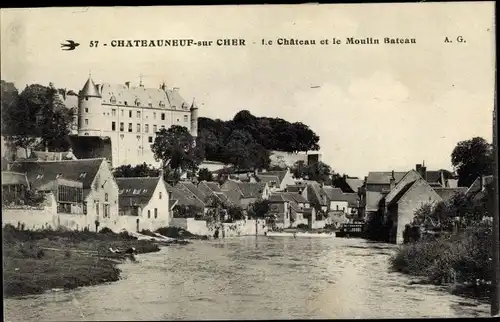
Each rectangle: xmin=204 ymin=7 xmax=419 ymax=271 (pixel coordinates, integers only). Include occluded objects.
xmin=451 ymin=137 xmax=493 ymax=187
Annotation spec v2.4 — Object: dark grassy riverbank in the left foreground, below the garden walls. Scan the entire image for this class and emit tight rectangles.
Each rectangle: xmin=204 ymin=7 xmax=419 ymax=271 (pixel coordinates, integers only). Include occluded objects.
xmin=2 ymin=226 xmax=159 ymax=297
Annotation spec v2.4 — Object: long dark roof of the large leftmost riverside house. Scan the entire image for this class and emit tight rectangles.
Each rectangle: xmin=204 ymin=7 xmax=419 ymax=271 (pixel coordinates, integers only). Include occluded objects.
xmin=11 ymin=158 xmax=105 ymax=197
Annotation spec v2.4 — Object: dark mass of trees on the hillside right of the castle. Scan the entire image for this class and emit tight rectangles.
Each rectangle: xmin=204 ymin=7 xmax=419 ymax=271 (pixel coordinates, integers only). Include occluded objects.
xmin=198 ymin=110 xmax=319 ymax=169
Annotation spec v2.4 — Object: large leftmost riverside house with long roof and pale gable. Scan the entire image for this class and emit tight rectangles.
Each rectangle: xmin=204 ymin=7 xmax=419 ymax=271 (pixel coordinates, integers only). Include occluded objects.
xmin=10 ymin=158 xmax=118 ymax=230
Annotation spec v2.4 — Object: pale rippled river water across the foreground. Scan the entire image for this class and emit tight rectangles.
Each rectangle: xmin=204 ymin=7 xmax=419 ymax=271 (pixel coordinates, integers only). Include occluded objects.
xmin=4 ymin=237 xmax=489 ymax=321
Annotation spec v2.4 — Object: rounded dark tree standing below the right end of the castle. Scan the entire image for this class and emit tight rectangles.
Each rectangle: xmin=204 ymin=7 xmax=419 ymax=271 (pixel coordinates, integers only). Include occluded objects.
xmin=151 ymin=125 xmax=203 ymax=184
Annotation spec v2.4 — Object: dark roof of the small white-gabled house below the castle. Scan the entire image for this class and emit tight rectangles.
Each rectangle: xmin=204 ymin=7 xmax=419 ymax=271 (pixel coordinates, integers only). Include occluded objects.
xmin=115 ymin=177 xmax=160 ymax=207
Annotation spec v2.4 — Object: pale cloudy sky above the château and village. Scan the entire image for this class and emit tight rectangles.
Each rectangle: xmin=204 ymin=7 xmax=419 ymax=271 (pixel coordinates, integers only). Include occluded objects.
xmin=0 ymin=2 xmax=495 ymax=178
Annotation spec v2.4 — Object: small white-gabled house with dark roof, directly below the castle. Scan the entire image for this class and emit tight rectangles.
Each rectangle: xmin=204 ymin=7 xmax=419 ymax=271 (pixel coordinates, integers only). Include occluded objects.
xmin=116 ymin=175 xmax=170 ymax=230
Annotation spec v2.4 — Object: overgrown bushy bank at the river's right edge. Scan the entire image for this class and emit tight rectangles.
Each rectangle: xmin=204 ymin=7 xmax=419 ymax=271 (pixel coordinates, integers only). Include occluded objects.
xmin=390 ymin=224 xmax=492 ymax=298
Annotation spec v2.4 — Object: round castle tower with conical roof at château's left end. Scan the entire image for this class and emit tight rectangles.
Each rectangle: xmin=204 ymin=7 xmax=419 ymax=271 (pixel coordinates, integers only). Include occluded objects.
xmin=78 ymin=76 xmax=102 ymax=136
